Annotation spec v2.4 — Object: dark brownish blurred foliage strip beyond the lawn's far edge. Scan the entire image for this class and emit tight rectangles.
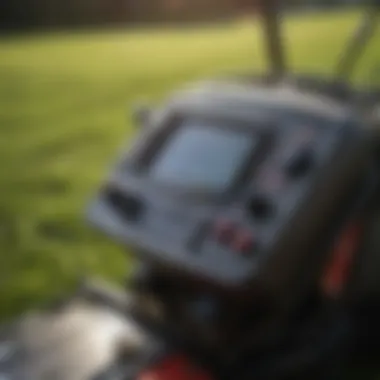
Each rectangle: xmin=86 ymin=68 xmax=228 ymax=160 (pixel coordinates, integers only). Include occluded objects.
xmin=0 ymin=0 xmax=362 ymax=31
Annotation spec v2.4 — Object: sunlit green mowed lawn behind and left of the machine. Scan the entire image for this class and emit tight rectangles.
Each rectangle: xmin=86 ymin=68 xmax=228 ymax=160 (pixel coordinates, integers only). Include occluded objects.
xmin=0 ymin=12 xmax=380 ymax=320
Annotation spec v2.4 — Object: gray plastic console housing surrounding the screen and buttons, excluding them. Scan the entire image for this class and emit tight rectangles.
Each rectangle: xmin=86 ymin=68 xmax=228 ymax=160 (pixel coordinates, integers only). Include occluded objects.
xmin=88 ymin=82 xmax=373 ymax=307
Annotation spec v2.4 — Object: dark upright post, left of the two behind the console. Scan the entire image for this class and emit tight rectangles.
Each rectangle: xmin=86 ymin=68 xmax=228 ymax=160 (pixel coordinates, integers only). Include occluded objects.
xmin=259 ymin=0 xmax=286 ymax=80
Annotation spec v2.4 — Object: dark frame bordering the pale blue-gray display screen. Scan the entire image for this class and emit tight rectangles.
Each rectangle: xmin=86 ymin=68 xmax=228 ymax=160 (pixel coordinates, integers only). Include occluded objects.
xmin=134 ymin=113 xmax=274 ymax=201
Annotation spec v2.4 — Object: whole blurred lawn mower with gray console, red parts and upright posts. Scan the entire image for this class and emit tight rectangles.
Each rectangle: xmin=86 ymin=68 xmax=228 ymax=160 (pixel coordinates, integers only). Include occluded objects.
xmin=0 ymin=0 xmax=380 ymax=380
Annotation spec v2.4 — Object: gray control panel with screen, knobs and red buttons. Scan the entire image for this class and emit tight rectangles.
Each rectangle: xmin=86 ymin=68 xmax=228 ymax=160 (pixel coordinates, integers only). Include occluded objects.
xmin=89 ymin=81 xmax=371 ymax=308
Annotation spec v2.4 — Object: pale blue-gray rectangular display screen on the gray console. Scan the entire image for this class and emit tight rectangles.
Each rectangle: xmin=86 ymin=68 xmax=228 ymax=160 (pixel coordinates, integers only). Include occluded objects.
xmin=149 ymin=121 xmax=257 ymax=191
